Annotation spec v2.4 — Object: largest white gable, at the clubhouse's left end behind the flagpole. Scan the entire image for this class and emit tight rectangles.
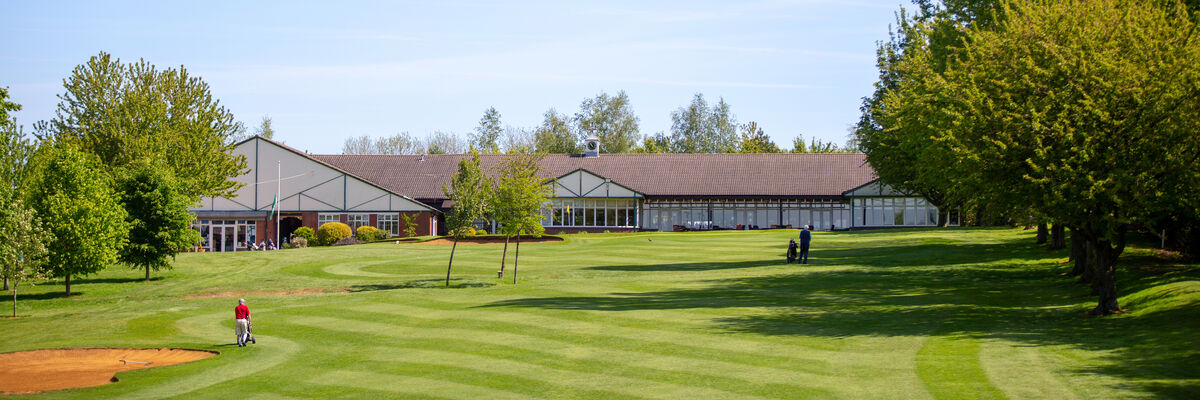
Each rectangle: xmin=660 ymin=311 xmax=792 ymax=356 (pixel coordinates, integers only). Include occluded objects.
xmin=192 ymin=137 xmax=432 ymax=211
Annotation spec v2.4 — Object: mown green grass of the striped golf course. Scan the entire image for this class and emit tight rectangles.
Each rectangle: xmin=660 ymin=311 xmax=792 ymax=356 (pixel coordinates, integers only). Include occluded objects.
xmin=0 ymin=228 xmax=1200 ymax=399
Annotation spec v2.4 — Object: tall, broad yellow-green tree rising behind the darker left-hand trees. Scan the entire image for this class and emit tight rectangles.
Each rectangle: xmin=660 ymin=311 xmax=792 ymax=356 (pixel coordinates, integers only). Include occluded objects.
xmin=36 ymin=53 xmax=246 ymax=197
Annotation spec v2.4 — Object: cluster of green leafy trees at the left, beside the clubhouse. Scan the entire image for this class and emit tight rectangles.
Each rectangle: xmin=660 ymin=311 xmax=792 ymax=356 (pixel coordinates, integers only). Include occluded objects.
xmin=0 ymin=53 xmax=246 ymax=316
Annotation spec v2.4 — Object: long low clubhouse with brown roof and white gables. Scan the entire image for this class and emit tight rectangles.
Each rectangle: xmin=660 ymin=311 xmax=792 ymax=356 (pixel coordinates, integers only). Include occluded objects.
xmin=192 ymin=136 xmax=940 ymax=251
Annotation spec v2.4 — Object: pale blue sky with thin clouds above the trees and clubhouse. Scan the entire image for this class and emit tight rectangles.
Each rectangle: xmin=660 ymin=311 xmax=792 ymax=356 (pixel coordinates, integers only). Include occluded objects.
xmin=0 ymin=0 xmax=907 ymax=154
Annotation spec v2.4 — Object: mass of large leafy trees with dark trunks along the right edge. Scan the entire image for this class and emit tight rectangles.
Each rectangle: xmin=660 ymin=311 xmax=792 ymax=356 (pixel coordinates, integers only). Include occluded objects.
xmin=854 ymin=0 xmax=1200 ymax=315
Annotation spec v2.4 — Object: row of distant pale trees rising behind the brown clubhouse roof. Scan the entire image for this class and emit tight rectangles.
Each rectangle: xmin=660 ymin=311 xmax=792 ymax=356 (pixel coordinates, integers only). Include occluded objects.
xmin=342 ymin=91 xmax=858 ymax=154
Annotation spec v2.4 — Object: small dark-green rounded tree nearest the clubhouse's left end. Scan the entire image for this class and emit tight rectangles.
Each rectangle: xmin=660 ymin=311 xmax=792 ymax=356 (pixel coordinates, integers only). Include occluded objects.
xmin=116 ymin=163 xmax=200 ymax=281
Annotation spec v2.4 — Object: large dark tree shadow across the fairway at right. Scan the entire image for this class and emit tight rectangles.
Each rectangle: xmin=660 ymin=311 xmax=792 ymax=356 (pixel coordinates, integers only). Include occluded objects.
xmin=484 ymin=231 xmax=1200 ymax=399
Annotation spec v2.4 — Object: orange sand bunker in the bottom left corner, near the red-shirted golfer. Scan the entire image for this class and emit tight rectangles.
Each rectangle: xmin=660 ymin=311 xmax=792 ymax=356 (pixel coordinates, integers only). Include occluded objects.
xmin=0 ymin=348 xmax=216 ymax=394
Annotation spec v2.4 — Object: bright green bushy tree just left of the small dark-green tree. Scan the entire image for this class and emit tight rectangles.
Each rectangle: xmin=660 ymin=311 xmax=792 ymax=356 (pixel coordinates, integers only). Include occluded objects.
xmin=28 ymin=143 xmax=130 ymax=295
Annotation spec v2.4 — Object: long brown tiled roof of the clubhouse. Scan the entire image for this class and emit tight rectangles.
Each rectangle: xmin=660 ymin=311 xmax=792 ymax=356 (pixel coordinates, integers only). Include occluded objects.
xmin=312 ymin=154 xmax=876 ymax=199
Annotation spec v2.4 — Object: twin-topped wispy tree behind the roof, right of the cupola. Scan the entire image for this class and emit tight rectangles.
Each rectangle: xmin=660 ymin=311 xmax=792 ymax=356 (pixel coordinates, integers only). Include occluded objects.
xmin=671 ymin=94 xmax=738 ymax=153
